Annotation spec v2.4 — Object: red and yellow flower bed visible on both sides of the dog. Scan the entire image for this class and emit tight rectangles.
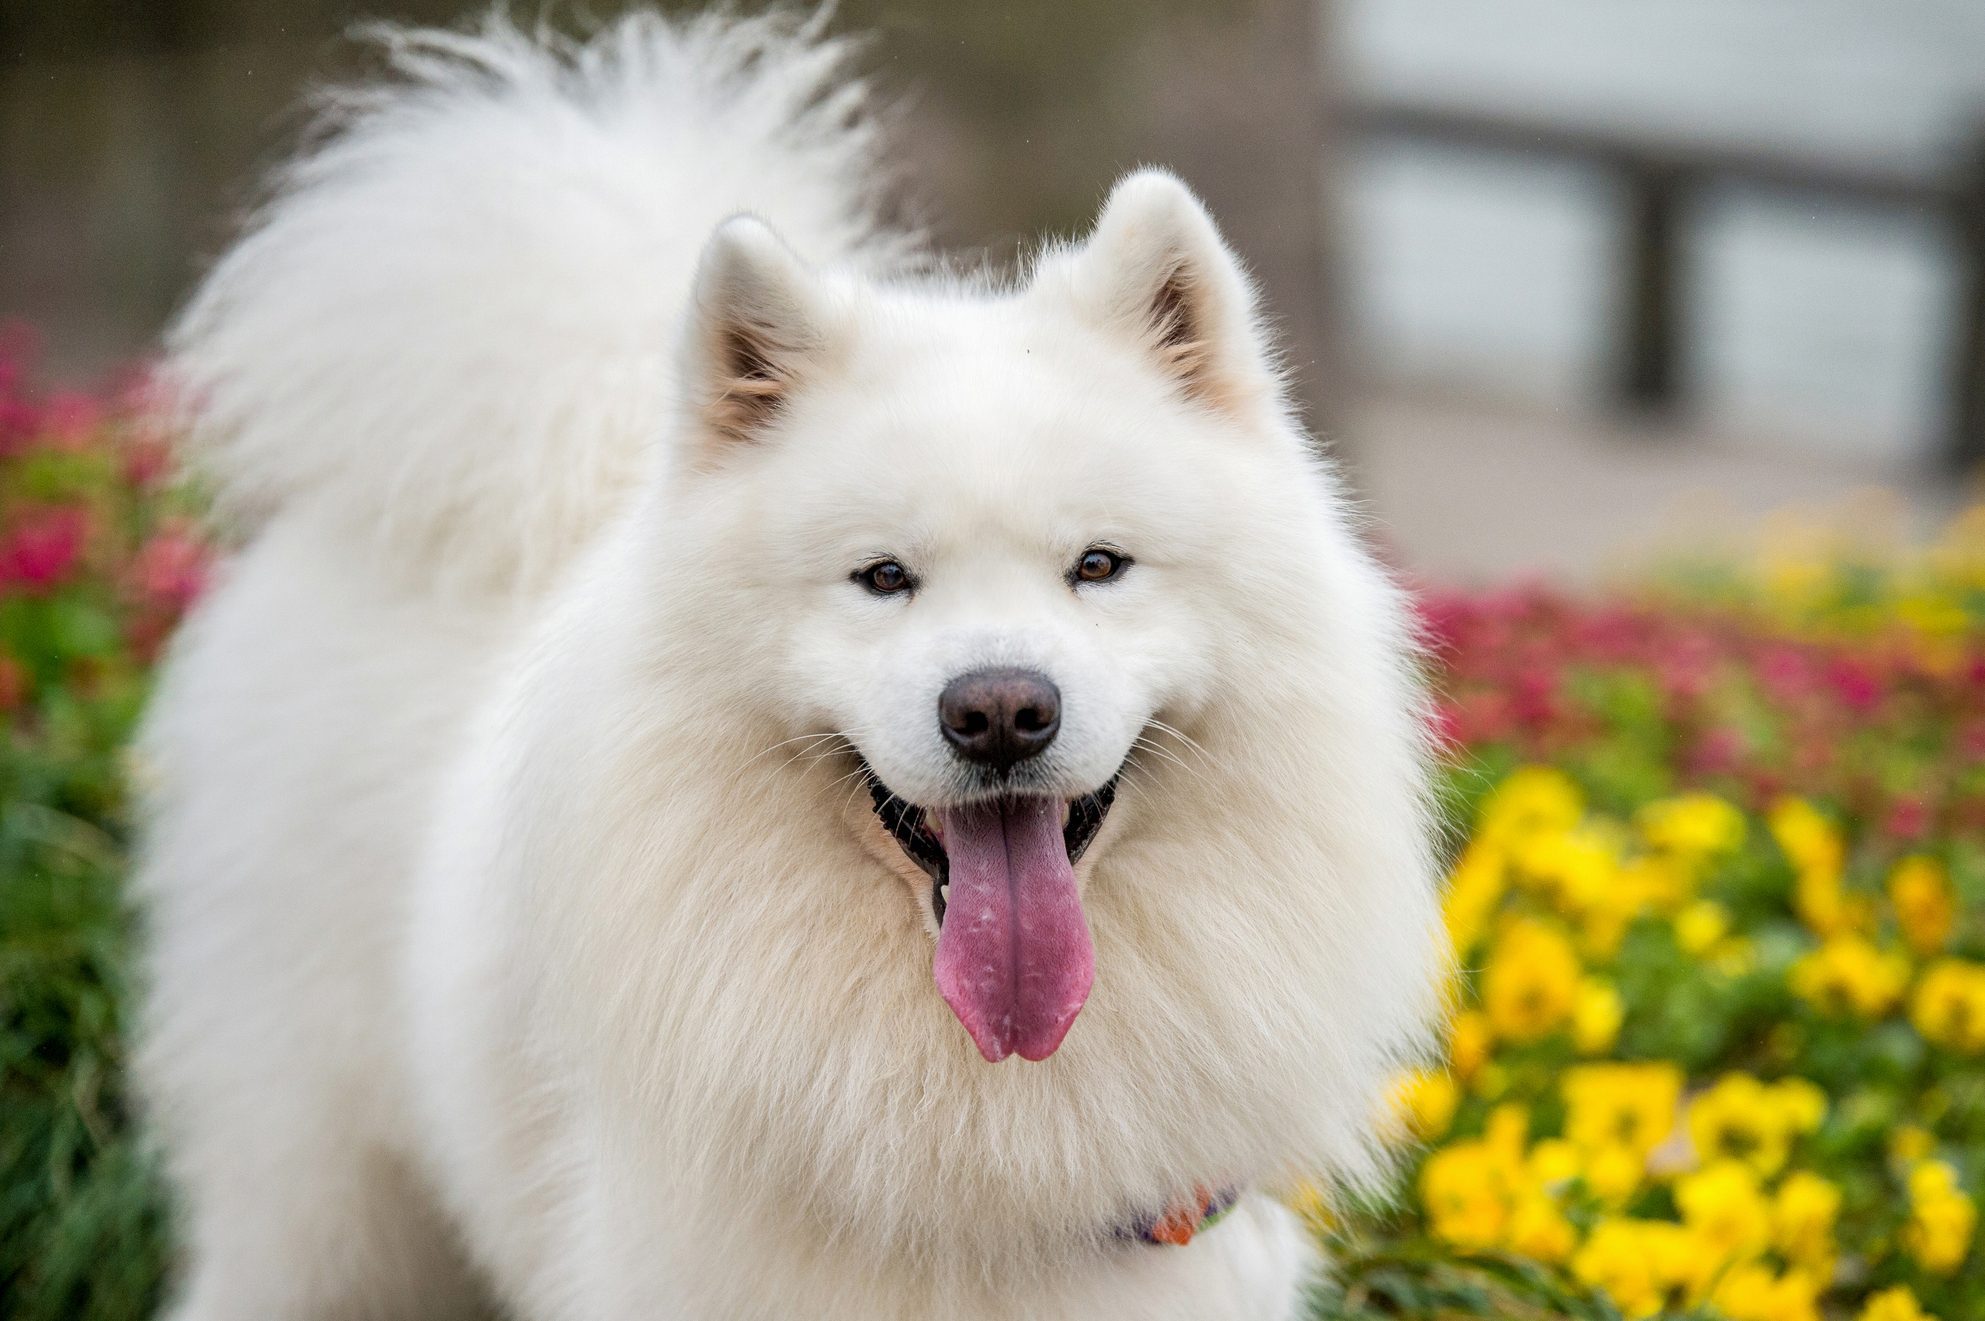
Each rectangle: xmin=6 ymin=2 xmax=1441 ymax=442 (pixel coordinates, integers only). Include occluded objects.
xmin=0 ymin=338 xmax=1985 ymax=1321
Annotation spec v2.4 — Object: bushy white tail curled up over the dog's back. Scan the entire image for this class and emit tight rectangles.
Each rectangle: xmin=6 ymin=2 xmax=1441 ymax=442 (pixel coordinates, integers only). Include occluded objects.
xmin=167 ymin=5 xmax=911 ymax=588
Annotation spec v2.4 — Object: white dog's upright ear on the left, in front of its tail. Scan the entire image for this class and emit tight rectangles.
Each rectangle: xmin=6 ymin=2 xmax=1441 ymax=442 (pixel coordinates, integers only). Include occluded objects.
xmin=685 ymin=217 xmax=824 ymax=445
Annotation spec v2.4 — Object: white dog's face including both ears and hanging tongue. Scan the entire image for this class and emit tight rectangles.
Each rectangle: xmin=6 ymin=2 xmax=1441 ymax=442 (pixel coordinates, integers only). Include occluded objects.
xmin=683 ymin=175 xmax=1333 ymax=1061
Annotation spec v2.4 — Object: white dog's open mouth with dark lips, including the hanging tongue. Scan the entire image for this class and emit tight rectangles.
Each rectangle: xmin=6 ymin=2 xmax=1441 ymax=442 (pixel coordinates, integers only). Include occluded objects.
xmin=861 ymin=763 xmax=1118 ymax=1063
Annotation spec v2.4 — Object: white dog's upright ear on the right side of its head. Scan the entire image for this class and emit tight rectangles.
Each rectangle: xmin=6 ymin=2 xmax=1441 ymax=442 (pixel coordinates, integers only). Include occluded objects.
xmin=1068 ymin=169 xmax=1276 ymax=409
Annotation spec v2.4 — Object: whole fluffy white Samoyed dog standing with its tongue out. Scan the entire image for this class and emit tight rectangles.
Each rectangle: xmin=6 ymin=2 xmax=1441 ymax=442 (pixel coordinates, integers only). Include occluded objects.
xmin=139 ymin=16 xmax=1443 ymax=1321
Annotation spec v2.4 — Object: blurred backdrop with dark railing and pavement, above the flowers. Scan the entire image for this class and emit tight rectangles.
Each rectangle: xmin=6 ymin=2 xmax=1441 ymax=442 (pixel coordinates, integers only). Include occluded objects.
xmin=0 ymin=0 xmax=1985 ymax=580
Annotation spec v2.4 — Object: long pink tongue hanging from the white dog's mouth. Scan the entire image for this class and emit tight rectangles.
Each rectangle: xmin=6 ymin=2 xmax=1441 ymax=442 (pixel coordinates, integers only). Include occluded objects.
xmin=931 ymin=799 xmax=1096 ymax=1063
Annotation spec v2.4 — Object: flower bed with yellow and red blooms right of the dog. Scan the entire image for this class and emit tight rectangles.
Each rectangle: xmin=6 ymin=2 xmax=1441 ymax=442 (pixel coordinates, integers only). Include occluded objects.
xmin=1312 ymin=560 xmax=1985 ymax=1321
